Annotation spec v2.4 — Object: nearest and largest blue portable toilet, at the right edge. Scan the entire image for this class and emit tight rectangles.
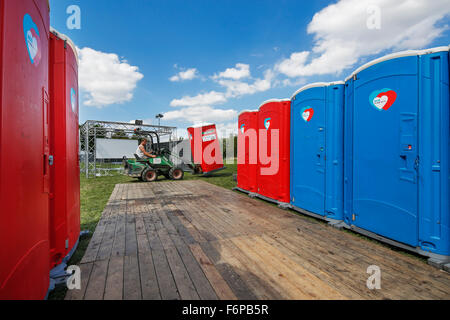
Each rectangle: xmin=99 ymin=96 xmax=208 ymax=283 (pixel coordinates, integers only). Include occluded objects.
xmin=344 ymin=47 xmax=450 ymax=263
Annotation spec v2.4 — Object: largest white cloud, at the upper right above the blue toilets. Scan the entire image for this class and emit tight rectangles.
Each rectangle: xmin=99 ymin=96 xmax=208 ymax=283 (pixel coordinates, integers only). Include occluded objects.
xmin=275 ymin=0 xmax=450 ymax=77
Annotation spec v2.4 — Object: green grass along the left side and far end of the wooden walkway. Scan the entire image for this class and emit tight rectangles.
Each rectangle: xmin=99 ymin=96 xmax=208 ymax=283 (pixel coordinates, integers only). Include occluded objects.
xmin=49 ymin=164 xmax=237 ymax=300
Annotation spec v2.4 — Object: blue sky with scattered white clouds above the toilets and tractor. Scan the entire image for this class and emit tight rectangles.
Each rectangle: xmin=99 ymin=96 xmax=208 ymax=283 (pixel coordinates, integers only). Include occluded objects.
xmin=50 ymin=0 xmax=450 ymax=136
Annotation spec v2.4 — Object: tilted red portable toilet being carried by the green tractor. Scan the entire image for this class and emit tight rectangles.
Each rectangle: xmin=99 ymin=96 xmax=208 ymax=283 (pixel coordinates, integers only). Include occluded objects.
xmin=187 ymin=124 xmax=224 ymax=174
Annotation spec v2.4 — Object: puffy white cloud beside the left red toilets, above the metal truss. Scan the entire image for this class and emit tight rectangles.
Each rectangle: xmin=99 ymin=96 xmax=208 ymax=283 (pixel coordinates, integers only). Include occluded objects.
xmin=78 ymin=48 xmax=144 ymax=108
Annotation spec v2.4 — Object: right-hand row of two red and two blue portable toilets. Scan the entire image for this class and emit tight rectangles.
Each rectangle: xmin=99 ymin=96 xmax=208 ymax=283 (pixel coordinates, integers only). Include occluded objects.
xmin=238 ymin=47 xmax=450 ymax=265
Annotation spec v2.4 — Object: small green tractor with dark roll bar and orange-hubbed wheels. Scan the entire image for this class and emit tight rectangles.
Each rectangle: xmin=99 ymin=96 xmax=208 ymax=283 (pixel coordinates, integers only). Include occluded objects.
xmin=123 ymin=131 xmax=184 ymax=182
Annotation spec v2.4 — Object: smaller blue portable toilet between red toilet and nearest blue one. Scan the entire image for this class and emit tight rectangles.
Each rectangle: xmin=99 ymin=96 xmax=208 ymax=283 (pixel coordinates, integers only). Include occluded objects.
xmin=290 ymin=81 xmax=345 ymax=224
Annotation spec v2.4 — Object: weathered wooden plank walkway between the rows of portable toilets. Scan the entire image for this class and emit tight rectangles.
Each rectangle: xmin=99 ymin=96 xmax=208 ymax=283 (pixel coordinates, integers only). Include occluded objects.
xmin=66 ymin=181 xmax=450 ymax=300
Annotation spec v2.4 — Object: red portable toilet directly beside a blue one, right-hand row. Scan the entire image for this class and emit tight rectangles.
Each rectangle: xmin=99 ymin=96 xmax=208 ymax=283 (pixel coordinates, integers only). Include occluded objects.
xmin=257 ymin=99 xmax=291 ymax=207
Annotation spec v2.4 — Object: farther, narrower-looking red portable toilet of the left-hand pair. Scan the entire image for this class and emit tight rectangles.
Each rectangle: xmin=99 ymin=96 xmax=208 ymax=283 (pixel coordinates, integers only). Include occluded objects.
xmin=50 ymin=29 xmax=80 ymax=267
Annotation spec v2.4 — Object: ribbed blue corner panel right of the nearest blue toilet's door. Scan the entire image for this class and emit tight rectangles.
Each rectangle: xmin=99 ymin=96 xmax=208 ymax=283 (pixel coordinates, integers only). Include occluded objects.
xmin=418 ymin=48 xmax=450 ymax=263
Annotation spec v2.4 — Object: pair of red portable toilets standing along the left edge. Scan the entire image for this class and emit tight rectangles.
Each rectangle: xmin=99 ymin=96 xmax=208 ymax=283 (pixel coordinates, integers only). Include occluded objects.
xmin=0 ymin=0 xmax=80 ymax=300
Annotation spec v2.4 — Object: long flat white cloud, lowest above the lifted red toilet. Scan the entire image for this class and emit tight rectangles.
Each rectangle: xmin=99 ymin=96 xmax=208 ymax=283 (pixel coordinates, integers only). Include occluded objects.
xmin=164 ymin=106 xmax=237 ymax=123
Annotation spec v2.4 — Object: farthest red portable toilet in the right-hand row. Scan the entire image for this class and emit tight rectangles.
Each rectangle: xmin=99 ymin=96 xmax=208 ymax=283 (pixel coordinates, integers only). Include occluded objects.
xmin=237 ymin=110 xmax=258 ymax=193
